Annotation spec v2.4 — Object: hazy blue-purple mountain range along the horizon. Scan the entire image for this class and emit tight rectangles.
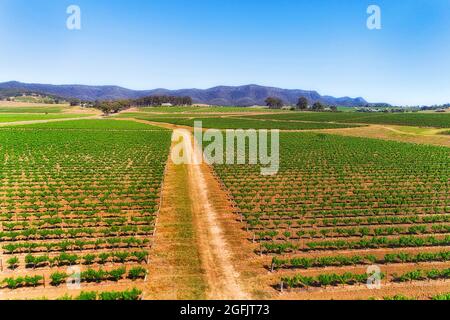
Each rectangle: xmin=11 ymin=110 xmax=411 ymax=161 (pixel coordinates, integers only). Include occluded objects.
xmin=0 ymin=81 xmax=387 ymax=107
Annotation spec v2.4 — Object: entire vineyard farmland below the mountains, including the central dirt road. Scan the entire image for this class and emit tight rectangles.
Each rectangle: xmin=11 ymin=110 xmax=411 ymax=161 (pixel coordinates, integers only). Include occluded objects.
xmin=0 ymin=106 xmax=450 ymax=300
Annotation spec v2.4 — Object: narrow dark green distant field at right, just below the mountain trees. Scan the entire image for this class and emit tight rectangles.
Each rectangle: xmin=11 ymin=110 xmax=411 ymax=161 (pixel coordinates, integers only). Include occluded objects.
xmin=246 ymin=112 xmax=450 ymax=128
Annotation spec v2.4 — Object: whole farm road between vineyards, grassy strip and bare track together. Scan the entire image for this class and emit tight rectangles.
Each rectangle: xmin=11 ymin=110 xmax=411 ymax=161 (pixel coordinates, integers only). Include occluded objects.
xmin=133 ymin=121 xmax=251 ymax=300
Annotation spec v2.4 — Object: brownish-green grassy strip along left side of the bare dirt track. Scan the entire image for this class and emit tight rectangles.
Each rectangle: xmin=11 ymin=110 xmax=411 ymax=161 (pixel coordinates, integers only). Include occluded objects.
xmin=144 ymin=149 xmax=207 ymax=300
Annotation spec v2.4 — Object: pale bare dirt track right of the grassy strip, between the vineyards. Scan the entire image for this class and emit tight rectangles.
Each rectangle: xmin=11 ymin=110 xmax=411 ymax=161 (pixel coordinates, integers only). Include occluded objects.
xmin=134 ymin=121 xmax=251 ymax=300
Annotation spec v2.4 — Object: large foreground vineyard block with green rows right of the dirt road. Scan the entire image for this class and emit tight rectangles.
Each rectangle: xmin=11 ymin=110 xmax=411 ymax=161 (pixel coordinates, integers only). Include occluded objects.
xmin=207 ymin=133 xmax=450 ymax=298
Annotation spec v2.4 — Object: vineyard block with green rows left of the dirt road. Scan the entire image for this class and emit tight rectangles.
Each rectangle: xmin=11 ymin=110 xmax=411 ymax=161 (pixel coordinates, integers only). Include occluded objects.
xmin=0 ymin=120 xmax=170 ymax=299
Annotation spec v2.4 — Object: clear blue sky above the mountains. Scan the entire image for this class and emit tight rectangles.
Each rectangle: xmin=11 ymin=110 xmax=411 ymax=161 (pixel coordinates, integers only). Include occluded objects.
xmin=0 ymin=0 xmax=450 ymax=105
